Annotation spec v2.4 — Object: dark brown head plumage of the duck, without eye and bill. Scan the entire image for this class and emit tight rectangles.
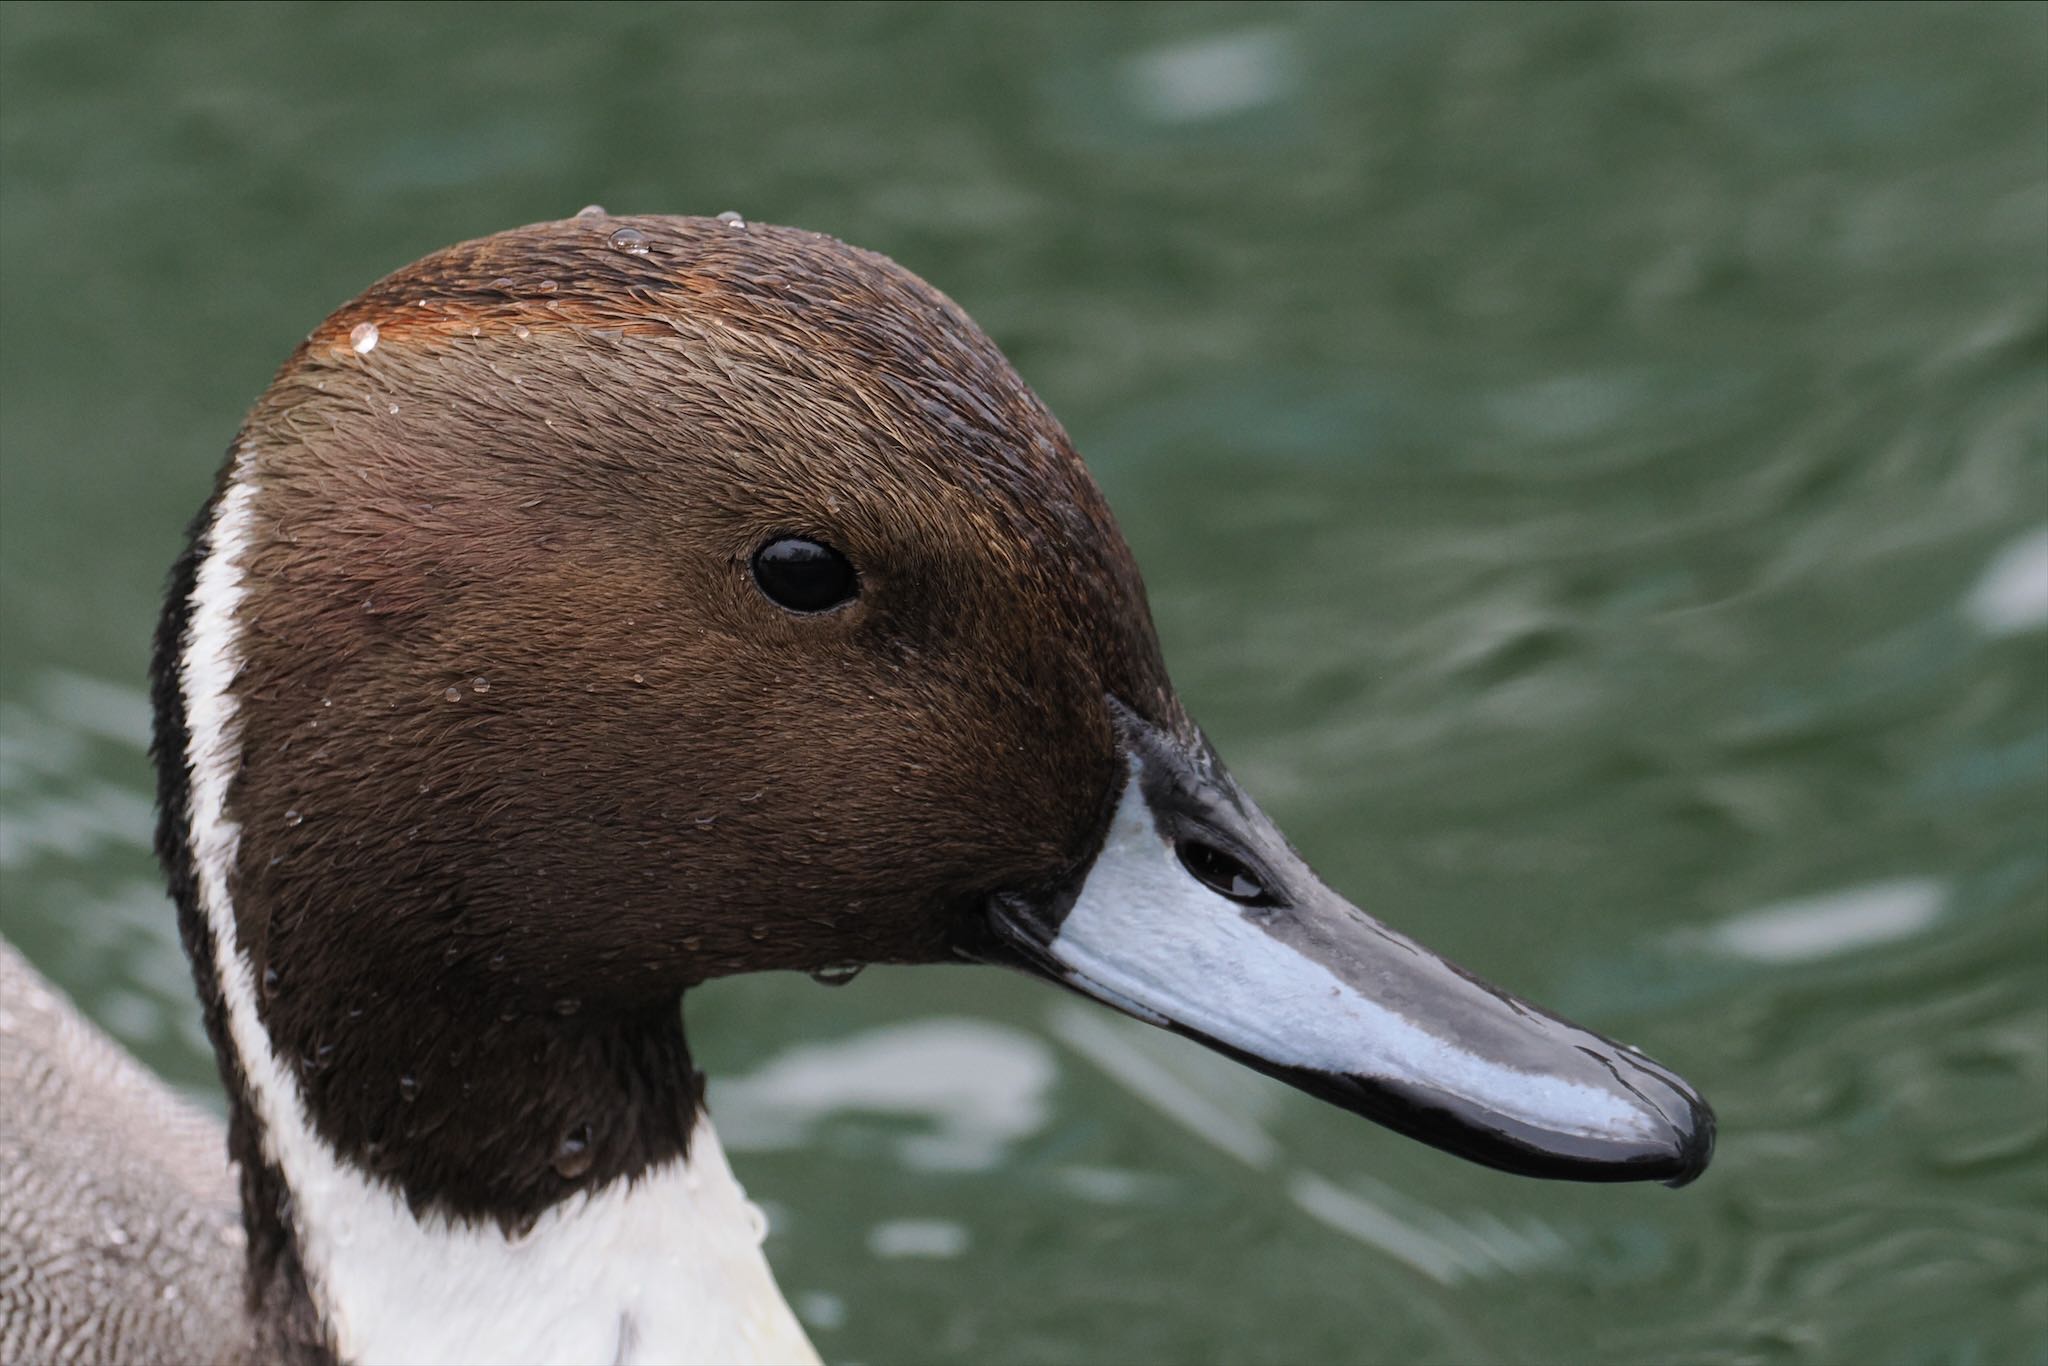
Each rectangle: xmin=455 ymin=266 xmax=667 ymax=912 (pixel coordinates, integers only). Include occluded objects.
xmin=160 ymin=217 xmax=1188 ymax=1253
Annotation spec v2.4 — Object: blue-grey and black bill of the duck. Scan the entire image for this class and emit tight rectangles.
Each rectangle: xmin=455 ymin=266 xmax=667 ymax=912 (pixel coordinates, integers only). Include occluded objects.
xmin=989 ymin=713 xmax=1714 ymax=1186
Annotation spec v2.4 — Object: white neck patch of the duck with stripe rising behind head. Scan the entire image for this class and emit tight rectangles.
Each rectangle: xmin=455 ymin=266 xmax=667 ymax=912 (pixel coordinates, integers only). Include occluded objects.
xmin=178 ymin=449 xmax=817 ymax=1364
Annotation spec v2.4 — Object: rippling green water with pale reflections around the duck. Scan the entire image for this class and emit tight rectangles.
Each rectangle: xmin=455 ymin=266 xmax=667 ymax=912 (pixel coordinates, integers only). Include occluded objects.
xmin=0 ymin=4 xmax=2048 ymax=1364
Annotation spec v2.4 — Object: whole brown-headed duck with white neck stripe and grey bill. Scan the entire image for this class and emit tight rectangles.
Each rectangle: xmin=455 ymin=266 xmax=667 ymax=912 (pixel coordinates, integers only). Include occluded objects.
xmin=0 ymin=213 xmax=1712 ymax=1362
